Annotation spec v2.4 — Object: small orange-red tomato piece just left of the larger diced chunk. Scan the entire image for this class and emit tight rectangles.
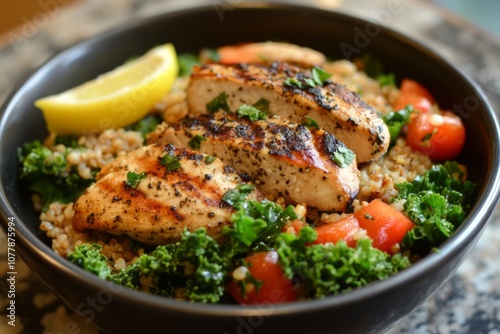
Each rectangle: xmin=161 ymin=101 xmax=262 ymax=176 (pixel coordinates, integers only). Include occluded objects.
xmin=314 ymin=214 xmax=359 ymax=247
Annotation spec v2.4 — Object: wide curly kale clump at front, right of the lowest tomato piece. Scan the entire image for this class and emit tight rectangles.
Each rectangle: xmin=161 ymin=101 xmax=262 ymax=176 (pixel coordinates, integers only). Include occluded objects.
xmin=276 ymin=227 xmax=410 ymax=298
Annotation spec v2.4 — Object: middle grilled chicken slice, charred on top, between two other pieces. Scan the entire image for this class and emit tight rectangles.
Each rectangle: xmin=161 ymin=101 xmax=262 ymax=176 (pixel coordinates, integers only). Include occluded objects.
xmin=148 ymin=113 xmax=359 ymax=211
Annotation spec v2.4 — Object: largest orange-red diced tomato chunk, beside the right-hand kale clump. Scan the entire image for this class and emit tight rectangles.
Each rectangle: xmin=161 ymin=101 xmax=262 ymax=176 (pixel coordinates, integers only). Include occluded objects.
xmin=354 ymin=199 xmax=414 ymax=254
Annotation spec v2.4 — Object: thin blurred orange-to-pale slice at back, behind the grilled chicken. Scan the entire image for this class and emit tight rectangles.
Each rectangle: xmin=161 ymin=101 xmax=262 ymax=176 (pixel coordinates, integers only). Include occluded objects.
xmin=200 ymin=41 xmax=326 ymax=67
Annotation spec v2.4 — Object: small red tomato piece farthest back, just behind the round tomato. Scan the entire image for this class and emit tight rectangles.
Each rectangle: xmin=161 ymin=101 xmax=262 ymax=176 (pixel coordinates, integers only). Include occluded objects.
xmin=392 ymin=79 xmax=436 ymax=112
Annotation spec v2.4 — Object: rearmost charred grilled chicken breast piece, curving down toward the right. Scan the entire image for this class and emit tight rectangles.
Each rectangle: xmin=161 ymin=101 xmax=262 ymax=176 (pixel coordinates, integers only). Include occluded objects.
xmin=187 ymin=63 xmax=390 ymax=163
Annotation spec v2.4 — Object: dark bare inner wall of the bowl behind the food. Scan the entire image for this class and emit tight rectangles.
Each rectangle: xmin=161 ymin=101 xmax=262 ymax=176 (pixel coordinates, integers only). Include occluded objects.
xmin=0 ymin=5 xmax=498 ymax=334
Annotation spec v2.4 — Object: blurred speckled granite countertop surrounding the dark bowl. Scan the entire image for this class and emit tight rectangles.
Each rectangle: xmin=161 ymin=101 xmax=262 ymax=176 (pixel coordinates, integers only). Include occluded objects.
xmin=0 ymin=0 xmax=500 ymax=334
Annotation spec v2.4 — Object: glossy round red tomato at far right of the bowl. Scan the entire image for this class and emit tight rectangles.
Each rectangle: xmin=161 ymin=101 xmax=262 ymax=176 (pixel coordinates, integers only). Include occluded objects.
xmin=406 ymin=112 xmax=465 ymax=161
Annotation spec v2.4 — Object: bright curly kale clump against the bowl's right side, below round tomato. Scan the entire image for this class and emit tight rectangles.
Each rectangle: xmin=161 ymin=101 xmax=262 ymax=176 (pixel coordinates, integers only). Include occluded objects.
xmin=396 ymin=162 xmax=477 ymax=255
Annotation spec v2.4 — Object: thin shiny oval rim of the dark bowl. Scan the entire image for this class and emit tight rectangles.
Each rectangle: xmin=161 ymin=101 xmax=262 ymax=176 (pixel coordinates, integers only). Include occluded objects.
xmin=0 ymin=1 xmax=500 ymax=317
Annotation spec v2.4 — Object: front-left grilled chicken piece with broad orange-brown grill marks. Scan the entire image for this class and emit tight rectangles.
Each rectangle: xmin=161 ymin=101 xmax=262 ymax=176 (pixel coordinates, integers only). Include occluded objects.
xmin=73 ymin=145 xmax=263 ymax=245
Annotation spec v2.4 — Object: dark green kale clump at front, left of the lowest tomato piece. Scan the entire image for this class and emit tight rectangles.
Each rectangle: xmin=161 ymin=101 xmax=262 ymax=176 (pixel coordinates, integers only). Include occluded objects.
xmin=108 ymin=229 xmax=227 ymax=303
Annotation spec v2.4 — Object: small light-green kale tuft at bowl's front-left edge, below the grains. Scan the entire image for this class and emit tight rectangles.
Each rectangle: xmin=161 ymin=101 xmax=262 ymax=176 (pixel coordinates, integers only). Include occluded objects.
xmin=67 ymin=243 xmax=111 ymax=278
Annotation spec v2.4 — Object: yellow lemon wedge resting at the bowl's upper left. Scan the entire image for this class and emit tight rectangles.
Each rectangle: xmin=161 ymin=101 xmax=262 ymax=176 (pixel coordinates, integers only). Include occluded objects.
xmin=35 ymin=44 xmax=178 ymax=134
